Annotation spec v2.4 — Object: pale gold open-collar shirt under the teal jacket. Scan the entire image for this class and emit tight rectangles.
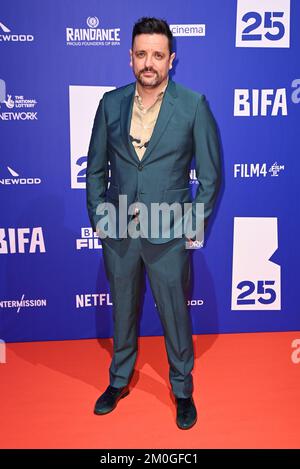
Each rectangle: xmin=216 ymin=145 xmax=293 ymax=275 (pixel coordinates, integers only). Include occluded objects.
xmin=130 ymin=78 xmax=169 ymax=218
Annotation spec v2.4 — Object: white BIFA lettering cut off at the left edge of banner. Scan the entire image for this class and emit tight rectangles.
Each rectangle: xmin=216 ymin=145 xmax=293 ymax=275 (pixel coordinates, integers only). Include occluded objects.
xmin=0 ymin=226 xmax=46 ymax=254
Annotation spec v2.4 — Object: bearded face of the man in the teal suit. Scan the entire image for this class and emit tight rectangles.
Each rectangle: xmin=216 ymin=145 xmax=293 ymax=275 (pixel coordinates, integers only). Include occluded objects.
xmin=130 ymin=34 xmax=175 ymax=88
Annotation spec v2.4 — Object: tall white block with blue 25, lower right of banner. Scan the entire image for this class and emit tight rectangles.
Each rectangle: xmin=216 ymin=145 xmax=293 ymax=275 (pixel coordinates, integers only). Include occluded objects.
xmin=231 ymin=217 xmax=281 ymax=310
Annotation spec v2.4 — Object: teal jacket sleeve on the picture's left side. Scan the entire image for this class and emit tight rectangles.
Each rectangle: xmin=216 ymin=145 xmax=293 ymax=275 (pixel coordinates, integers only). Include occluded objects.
xmin=86 ymin=93 xmax=108 ymax=231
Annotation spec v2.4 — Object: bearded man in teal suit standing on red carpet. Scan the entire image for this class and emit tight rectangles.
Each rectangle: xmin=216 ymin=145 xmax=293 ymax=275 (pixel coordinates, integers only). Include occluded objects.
xmin=87 ymin=18 xmax=221 ymax=429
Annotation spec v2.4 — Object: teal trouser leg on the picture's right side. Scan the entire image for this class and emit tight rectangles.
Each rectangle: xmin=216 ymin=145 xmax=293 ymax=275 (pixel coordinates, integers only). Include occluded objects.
xmin=144 ymin=239 xmax=194 ymax=398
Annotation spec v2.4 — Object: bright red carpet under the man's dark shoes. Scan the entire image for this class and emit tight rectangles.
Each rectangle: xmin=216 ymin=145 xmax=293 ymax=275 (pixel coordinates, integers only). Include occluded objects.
xmin=0 ymin=332 xmax=300 ymax=448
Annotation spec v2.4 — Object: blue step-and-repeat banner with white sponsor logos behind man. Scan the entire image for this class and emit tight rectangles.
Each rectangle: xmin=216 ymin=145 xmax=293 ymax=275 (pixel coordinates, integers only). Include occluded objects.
xmin=0 ymin=0 xmax=300 ymax=342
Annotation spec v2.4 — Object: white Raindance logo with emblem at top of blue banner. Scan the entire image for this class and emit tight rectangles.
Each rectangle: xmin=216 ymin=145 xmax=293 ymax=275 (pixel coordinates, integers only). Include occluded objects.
xmin=66 ymin=16 xmax=120 ymax=46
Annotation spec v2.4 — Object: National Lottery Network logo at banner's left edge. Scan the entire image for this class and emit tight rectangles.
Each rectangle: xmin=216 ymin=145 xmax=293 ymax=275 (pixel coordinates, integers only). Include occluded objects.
xmin=0 ymin=79 xmax=38 ymax=121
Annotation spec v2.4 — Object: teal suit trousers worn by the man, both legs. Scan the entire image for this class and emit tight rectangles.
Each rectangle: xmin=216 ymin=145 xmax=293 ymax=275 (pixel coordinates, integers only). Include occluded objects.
xmin=102 ymin=232 xmax=194 ymax=398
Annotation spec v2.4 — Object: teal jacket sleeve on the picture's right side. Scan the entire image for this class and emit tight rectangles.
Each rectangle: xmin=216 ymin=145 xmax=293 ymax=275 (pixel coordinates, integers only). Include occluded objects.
xmin=193 ymin=94 xmax=221 ymax=236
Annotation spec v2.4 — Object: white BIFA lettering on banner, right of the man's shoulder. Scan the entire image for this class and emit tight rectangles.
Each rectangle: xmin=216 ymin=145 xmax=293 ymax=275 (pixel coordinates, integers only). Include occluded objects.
xmin=233 ymin=88 xmax=288 ymax=117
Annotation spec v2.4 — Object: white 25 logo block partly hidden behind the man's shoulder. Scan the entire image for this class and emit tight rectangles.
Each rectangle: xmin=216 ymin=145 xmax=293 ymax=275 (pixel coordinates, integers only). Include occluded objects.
xmin=69 ymin=86 xmax=115 ymax=189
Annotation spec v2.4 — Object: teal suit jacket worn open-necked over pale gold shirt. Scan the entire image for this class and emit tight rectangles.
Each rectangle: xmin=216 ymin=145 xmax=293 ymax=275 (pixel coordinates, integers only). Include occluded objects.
xmin=86 ymin=79 xmax=221 ymax=243
